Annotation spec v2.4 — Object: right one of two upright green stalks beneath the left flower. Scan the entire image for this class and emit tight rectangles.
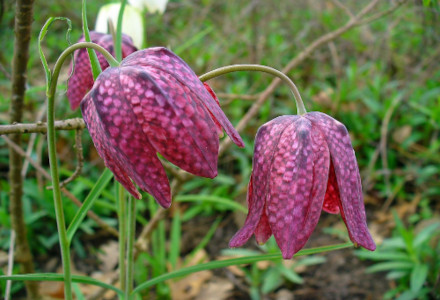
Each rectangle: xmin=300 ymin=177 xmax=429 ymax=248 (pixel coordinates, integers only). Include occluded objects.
xmin=125 ymin=197 xmax=136 ymax=300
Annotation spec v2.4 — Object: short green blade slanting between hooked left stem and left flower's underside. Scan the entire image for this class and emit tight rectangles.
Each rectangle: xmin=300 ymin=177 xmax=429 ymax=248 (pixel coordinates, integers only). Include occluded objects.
xmin=67 ymin=168 xmax=113 ymax=243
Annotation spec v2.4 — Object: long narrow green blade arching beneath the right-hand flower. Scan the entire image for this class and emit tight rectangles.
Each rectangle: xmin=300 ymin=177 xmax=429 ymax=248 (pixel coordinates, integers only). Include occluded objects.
xmin=133 ymin=242 xmax=353 ymax=293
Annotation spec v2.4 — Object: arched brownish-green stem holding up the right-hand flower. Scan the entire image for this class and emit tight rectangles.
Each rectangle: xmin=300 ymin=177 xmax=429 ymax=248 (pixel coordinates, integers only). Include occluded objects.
xmin=199 ymin=64 xmax=307 ymax=115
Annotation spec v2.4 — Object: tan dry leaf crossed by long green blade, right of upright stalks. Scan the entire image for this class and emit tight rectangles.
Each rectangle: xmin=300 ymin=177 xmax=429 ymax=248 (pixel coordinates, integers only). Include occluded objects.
xmin=168 ymin=249 xmax=212 ymax=300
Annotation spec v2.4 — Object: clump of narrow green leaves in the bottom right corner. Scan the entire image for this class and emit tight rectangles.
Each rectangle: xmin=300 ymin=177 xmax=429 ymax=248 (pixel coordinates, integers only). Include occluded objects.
xmin=357 ymin=213 xmax=440 ymax=300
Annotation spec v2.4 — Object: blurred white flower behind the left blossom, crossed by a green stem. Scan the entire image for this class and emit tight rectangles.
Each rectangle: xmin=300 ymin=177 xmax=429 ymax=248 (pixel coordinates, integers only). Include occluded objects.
xmin=95 ymin=3 xmax=145 ymax=49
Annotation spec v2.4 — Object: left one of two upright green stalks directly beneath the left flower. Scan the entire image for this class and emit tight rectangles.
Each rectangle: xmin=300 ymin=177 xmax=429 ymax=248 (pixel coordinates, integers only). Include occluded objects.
xmin=115 ymin=182 xmax=127 ymax=298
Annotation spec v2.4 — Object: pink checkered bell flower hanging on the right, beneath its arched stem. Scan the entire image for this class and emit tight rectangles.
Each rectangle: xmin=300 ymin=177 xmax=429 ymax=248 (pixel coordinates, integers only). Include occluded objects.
xmin=229 ymin=112 xmax=376 ymax=259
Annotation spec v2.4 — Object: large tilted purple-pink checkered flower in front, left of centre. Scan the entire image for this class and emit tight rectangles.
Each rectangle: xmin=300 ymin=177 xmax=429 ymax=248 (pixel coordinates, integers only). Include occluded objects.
xmin=81 ymin=48 xmax=244 ymax=207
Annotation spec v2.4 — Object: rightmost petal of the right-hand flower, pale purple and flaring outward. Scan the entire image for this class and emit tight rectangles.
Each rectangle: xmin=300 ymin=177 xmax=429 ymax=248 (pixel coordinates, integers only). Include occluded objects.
xmin=306 ymin=112 xmax=376 ymax=250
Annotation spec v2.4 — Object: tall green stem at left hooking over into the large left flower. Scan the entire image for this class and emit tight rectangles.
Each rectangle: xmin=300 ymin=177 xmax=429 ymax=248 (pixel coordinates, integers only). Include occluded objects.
xmin=47 ymin=42 xmax=119 ymax=300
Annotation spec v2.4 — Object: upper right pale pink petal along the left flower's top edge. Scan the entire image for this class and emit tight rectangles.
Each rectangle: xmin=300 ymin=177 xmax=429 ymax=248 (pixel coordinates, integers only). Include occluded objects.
xmin=121 ymin=47 xmax=244 ymax=147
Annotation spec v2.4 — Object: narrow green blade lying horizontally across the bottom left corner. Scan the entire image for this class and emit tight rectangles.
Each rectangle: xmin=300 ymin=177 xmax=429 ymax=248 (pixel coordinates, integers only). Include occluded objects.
xmin=0 ymin=273 xmax=123 ymax=296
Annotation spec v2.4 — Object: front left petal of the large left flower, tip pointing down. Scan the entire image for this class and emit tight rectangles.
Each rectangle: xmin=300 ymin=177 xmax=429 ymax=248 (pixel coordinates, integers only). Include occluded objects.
xmin=82 ymin=68 xmax=171 ymax=208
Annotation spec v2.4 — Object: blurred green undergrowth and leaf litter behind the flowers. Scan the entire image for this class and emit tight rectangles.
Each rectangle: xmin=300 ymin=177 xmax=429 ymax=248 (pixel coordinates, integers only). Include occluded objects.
xmin=0 ymin=0 xmax=440 ymax=299
